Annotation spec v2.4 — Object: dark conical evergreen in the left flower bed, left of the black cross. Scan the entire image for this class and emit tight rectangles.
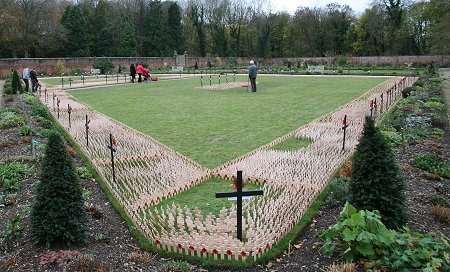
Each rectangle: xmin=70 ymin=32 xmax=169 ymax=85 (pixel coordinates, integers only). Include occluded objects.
xmin=30 ymin=132 xmax=88 ymax=247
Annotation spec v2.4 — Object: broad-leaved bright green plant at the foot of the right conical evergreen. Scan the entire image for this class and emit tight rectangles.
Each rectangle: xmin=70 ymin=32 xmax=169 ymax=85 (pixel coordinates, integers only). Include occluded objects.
xmin=319 ymin=203 xmax=394 ymax=261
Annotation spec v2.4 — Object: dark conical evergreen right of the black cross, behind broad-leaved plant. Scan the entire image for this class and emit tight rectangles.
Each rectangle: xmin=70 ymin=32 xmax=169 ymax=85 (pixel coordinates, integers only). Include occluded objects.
xmin=349 ymin=116 xmax=407 ymax=228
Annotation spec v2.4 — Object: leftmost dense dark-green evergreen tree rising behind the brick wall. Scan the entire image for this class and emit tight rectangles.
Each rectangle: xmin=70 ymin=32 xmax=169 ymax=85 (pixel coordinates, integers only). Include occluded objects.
xmin=61 ymin=5 xmax=90 ymax=57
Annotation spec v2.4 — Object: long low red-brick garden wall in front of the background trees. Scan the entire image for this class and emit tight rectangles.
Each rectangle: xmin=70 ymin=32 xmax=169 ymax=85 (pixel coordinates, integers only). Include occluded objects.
xmin=0 ymin=55 xmax=450 ymax=77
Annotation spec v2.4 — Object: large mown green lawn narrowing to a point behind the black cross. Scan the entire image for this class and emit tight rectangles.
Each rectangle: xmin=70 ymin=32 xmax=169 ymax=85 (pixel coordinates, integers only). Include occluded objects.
xmin=71 ymin=76 xmax=386 ymax=168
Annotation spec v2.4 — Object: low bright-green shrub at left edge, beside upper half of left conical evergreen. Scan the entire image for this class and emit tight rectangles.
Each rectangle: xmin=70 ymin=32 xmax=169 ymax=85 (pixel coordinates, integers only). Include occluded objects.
xmin=0 ymin=162 xmax=32 ymax=193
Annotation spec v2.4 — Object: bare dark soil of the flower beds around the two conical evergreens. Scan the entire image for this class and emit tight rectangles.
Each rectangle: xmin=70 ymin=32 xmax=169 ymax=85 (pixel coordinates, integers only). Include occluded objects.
xmin=0 ymin=73 xmax=450 ymax=271
